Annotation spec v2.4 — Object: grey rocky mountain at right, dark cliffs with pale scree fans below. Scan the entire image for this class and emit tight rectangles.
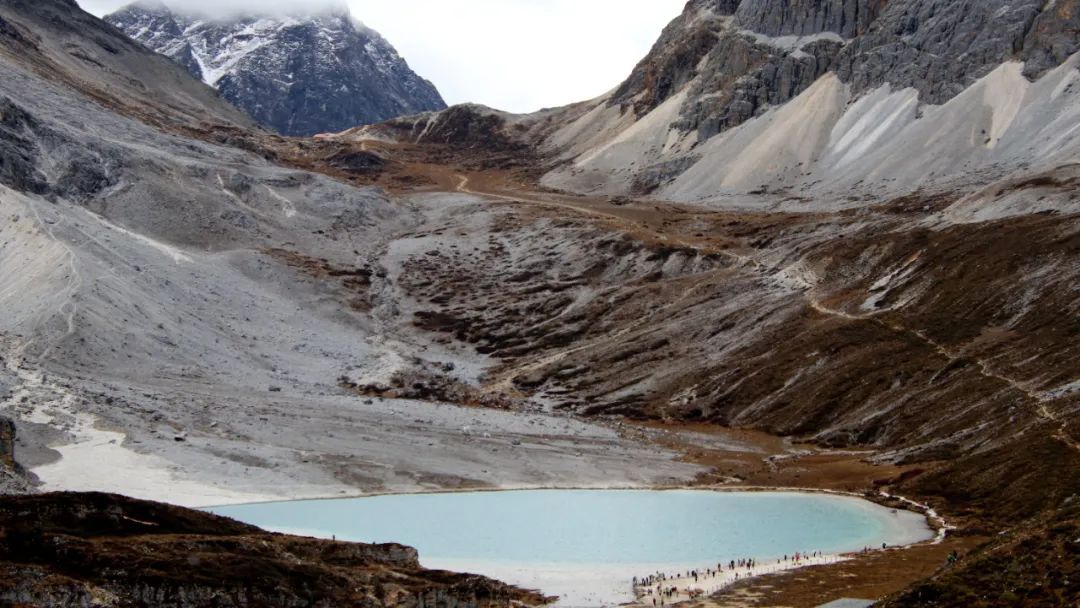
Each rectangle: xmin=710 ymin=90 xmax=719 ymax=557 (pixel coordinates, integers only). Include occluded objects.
xmin=537 ymin=0 xmax=1080 ymax=204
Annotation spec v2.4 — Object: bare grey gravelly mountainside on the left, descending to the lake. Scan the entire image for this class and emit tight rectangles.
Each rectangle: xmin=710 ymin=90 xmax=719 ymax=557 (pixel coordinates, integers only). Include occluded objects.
xmin=0 ymin=0 xmax=699 ymax=504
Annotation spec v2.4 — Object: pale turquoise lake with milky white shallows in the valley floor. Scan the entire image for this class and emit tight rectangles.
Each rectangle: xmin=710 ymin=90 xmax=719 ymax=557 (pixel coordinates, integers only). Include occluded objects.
xmin=210 ymin=490 xmax=933 ymax=606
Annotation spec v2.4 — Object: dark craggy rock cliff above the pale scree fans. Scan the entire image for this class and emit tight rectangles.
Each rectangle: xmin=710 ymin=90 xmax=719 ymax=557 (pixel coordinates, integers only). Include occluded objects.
xmin=607 ymin=0 xmax=1080 ymax=133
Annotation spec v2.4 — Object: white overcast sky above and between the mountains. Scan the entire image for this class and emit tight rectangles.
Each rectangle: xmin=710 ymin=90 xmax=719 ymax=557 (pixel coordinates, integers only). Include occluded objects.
xmin=79 ymin=0 xmax=686 ymax=112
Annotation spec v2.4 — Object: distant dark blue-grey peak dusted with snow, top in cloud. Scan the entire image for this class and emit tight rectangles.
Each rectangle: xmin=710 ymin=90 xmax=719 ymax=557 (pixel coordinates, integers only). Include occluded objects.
xmin=106 ymin=0 xmax=446 ymax=135
